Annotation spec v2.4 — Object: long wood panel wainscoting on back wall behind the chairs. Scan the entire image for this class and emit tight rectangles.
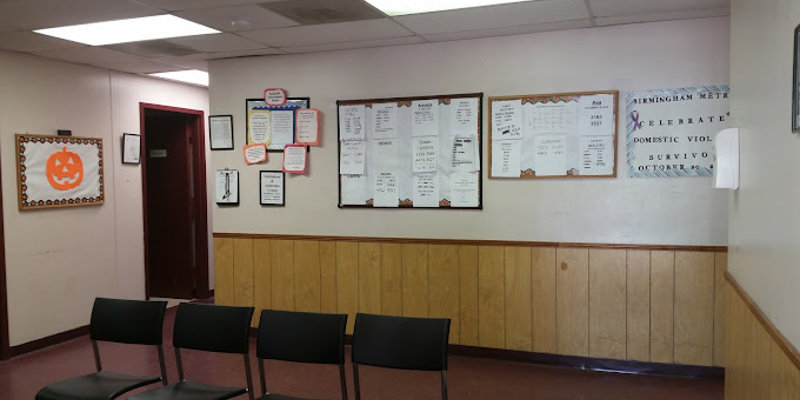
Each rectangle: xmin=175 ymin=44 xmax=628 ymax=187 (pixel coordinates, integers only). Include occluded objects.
xmin=214 ymin=233 xmax=727 ymax=367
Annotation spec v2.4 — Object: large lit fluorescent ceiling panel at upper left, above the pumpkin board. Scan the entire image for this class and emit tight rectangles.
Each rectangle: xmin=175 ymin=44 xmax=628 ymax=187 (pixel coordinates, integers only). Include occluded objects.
xmin=34 ymin=15 xmax=220 ymax=46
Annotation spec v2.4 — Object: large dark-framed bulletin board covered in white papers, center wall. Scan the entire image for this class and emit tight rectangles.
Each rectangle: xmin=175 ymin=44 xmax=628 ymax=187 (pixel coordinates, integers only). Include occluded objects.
xmin=336 ymin=93 xmax=483 ymax=209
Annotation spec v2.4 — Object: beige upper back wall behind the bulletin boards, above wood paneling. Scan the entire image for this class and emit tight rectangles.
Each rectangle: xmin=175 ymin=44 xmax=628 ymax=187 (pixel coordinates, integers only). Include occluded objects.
xmin=209 ymin=18 xmax=729 ymax=245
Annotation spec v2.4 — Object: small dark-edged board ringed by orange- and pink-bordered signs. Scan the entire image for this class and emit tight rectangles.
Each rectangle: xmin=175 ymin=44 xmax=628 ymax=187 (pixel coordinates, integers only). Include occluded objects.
xmin=245 ymin=97 xmax=311 ymax=151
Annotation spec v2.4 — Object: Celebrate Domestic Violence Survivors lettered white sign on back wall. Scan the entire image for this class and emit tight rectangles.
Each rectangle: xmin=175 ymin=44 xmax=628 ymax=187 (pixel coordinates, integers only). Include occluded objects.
xmin=625 ymin=85 xmax=730 ymax=178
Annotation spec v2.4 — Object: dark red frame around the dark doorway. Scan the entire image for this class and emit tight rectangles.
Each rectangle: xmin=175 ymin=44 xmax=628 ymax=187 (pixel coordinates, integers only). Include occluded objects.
xmin=139 ymin=103 xmax=211 ymax=299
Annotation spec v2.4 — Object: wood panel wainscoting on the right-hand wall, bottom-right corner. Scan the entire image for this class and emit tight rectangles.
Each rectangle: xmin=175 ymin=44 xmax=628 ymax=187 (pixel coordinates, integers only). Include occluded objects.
xmin=725 ymin=274 xmax=800 ymax=400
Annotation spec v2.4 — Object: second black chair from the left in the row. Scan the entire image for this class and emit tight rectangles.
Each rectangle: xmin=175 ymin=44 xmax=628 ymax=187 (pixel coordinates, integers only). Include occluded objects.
xmin=128 ymin=303 xmax=253 ymax=400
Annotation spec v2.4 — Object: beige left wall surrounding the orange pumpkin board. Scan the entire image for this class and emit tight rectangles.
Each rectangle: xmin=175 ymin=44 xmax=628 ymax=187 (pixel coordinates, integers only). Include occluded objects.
xmin=0 ymin=52 xmax=208 ymax=346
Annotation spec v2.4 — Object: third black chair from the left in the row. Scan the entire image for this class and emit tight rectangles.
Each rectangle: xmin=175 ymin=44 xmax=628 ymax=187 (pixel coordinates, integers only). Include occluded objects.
xmin=256 ymin=310 xmax=347 ymax=400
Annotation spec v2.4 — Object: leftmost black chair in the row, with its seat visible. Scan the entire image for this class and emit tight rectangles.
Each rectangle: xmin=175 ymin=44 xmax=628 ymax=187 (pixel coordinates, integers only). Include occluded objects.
xmin=36 ymin=298 xmax=167 ymax=400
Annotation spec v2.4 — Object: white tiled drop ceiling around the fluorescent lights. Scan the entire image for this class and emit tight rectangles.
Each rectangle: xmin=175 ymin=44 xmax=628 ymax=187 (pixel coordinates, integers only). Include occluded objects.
xmin=0 ymin=0 xmax=730 ymax=73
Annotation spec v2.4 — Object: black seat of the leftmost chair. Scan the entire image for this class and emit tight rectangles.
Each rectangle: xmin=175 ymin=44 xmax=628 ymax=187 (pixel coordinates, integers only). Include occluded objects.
xmin=36 ymin=371 xmax=161 ymax=400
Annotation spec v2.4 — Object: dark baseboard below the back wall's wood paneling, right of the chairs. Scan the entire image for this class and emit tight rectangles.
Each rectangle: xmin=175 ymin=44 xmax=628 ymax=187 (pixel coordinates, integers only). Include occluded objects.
xmin=449 ymin=344 xmax=725 ymax=380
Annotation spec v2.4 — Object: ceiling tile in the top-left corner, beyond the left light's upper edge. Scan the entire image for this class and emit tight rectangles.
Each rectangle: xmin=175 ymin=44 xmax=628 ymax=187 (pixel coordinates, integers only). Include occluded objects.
xmin=0 ymin=0 xmax=163 ymax=30
